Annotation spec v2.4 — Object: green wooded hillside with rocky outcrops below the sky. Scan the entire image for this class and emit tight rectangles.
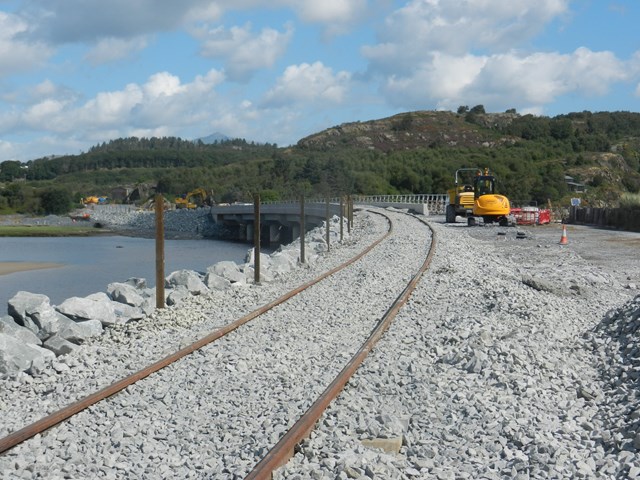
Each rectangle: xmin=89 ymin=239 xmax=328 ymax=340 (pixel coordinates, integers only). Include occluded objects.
xmin=0 ymin=109 xmax=640 ymax=214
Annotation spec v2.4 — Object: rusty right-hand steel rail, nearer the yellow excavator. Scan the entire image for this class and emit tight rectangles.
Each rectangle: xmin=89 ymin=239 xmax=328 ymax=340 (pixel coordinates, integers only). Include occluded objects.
xmin=245 ymin=217 xmax=436 ymax=480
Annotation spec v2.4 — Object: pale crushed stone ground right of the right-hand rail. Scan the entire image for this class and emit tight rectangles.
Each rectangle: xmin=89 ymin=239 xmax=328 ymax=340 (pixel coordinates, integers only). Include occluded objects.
xmin=282 ymin=224 xmax=640 ymax=479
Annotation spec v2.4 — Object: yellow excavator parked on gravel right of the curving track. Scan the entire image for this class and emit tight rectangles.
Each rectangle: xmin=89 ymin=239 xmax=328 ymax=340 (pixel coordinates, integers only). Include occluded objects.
xmin=445 ymin=168 xmax=513 ymax=226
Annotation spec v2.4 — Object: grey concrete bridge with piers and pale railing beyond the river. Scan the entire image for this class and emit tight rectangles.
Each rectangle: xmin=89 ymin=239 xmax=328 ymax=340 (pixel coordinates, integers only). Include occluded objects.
xmin=209 ymin=194 xmax=447 ymax=244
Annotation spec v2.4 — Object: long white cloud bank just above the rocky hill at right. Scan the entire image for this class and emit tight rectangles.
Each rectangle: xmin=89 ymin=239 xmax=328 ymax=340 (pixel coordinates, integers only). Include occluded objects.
xmin=383 ymin=48 xmax=629 ymax=111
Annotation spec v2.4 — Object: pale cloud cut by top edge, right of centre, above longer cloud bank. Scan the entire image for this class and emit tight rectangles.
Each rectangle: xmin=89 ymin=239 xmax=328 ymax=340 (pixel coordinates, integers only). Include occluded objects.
xmin=362 ymin=0 xmax=569 ymax=72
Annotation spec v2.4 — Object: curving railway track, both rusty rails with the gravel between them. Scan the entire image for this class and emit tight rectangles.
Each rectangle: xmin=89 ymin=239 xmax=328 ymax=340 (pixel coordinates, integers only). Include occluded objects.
xmin=0 ymin=208 xmax=432 ymax=478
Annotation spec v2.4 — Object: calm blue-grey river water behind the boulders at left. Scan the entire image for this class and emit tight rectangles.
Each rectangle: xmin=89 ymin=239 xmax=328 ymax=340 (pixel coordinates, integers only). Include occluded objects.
xmin=0 ymin=236 xmax=251 ymax=316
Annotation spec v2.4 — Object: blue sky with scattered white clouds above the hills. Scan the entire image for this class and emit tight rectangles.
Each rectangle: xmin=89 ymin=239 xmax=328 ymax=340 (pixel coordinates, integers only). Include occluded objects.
xmin=0 ymin=0 xmax=640 ymax=161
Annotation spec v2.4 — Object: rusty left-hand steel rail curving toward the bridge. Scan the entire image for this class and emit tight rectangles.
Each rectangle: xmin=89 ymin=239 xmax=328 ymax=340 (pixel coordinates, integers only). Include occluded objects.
xmin=0 ymin=211 xmax=393 ymax=454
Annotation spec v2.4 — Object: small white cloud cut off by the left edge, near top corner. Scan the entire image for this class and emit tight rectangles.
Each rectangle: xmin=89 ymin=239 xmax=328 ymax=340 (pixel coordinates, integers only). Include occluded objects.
xmin=0 ymin=12 xmax=53 ymax=77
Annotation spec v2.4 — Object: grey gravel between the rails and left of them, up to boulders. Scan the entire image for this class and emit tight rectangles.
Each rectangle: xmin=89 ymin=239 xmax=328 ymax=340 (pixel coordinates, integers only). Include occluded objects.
xmin=0 ymin=213 xmax=430 ymax=478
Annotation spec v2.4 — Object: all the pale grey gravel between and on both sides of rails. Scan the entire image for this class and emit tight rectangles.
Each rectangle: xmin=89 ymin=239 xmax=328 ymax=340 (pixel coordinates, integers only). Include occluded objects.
xmin=0 ymin=212 xmax=640 ymax=479
